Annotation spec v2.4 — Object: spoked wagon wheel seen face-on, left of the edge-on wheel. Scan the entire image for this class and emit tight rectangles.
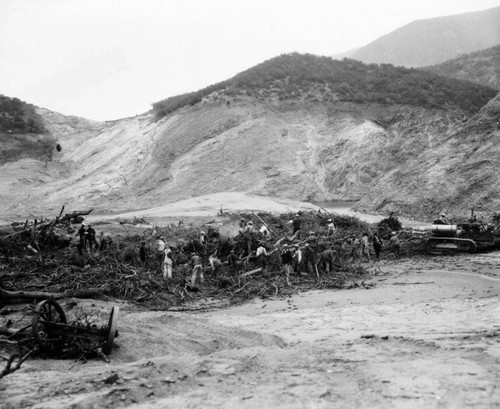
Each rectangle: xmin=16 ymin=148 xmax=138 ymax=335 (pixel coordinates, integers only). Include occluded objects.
xmin=31 ymin=300 xmax=67 ymax=353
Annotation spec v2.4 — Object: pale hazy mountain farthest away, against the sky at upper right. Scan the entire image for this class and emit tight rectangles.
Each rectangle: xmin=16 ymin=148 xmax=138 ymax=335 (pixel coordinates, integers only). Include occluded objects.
xmin=336 ymin=7 xmax=500 ymax=67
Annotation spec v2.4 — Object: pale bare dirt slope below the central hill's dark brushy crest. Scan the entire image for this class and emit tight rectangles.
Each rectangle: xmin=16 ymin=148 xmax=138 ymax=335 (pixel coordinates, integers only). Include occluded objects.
xmin=0 ymin=97 xmax=476 ymax=220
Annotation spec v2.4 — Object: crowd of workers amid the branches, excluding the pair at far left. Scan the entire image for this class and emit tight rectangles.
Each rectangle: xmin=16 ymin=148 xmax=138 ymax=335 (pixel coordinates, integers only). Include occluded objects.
xmin=139 ymin=213 xmax=406 ymax=286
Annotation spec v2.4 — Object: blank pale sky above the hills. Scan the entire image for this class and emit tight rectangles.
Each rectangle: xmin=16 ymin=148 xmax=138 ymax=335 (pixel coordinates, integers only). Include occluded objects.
xmin=0 ymin=0 xmax=500 ymax=120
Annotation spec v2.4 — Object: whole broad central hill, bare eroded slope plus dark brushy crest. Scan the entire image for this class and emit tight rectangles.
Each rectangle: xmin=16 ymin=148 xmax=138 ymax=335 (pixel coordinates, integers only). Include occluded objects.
xmin=0 ymin=55 xmax=498 ymax=217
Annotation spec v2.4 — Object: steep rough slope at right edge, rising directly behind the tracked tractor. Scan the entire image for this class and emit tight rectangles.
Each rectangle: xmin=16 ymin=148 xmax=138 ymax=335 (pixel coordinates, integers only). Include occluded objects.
xmin=357 ymin=95 xmax=500 ymax=217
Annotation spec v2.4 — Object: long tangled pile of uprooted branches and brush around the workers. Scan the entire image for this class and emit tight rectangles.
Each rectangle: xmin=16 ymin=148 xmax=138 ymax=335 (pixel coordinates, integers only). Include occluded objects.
xmin=0 ymin=208 xmax=398 ymax=308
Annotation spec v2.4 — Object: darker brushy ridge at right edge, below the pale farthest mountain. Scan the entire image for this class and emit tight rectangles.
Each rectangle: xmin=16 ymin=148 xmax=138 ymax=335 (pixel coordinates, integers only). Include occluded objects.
xmin=422 ymin=45 xmax=500 ymax=90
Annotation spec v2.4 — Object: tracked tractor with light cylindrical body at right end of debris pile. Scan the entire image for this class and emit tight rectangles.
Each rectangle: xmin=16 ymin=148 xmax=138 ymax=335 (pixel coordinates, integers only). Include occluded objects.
xmin=426 ymin=212 xmax=500 ymax=254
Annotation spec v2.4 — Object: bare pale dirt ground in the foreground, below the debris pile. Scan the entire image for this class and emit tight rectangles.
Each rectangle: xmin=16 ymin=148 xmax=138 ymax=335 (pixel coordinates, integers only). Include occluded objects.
xmin=0 ymin=252 xmax=500 ymax=409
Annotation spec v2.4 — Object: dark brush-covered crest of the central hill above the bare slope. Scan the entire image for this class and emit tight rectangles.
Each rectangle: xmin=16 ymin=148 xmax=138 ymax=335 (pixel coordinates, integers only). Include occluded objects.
xmin=153 ymin=53 xmax=495 ymax=118
